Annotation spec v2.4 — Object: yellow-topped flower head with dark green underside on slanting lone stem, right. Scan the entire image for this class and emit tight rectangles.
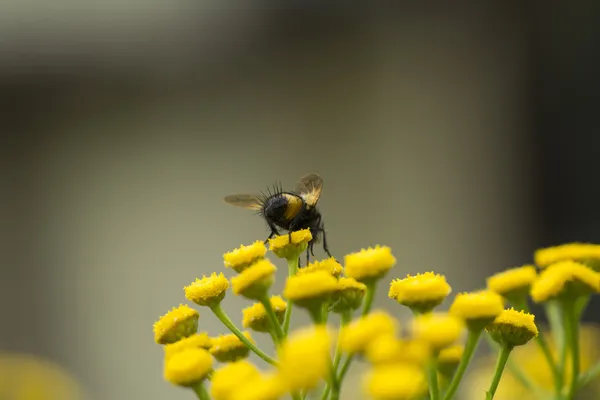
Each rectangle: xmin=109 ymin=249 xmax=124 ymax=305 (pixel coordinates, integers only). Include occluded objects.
xmin=486 ymin=308 xmax=538 ymax=347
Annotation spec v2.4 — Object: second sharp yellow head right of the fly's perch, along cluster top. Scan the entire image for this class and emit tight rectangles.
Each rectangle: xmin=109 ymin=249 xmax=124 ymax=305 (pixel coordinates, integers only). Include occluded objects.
xmin=388 ymin=272 xmax=452 ymax=312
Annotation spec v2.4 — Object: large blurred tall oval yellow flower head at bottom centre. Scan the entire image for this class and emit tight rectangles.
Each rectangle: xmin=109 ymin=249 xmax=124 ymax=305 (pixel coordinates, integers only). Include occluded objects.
xmin=279 ymin=326 xmax=332 ymax=391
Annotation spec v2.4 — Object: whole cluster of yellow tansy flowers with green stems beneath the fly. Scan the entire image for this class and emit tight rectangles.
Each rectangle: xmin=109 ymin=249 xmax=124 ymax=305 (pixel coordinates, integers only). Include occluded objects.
xmin=154 ymin=234 xmax=600 ymax=400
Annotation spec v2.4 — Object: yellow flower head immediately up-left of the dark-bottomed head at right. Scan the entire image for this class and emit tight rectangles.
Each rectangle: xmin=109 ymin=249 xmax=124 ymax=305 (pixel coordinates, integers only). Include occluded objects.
xmin=450 ymin=290 xmax=504 ymax=330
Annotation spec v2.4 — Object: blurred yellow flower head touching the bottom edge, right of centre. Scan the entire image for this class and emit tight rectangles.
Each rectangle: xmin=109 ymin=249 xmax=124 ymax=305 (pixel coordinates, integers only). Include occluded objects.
xmin=364 ymin=364 xmax=427 ymax=400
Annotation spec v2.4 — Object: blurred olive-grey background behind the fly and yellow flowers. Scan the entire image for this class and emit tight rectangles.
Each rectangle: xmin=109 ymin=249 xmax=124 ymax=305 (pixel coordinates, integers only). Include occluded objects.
xmin=0 ymin=0 xmax=600 ymax=400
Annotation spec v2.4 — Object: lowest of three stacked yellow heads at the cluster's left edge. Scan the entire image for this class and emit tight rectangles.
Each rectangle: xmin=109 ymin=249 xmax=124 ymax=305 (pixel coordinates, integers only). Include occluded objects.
xmin=164 ymin=348 xmax=213 ymax=386
